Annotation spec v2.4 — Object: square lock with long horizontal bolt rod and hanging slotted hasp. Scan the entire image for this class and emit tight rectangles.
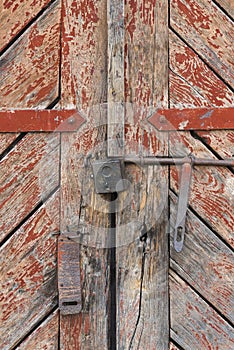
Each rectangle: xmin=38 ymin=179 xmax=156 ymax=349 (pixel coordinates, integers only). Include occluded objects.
xmin=92 ymin=154 xmax=234 ymax=252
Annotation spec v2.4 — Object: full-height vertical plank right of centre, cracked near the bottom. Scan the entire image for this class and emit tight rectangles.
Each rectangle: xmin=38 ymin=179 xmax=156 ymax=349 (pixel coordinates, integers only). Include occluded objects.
xmin=116 ymin=0 xmax=169 ymax=350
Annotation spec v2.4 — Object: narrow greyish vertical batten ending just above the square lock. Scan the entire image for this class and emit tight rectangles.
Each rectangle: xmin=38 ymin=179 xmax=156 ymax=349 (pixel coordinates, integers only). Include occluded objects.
xmin=107 ymin=0 xmax=125 ymax=157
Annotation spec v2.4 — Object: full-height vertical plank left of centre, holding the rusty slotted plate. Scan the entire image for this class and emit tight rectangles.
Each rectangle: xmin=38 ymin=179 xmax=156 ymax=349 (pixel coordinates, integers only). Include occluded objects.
xmin=60 ymin=0 xmax=109 ymax=350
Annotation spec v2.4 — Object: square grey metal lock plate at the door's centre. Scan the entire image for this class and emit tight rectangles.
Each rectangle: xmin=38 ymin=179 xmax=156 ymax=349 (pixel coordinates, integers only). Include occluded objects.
xmin=92 ymin=160 xmax=124 ymax=193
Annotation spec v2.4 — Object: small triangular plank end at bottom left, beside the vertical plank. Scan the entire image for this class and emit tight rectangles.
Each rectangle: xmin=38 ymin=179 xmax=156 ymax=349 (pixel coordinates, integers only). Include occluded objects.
xmin=16 ymin=311 xmax=59 ymax=350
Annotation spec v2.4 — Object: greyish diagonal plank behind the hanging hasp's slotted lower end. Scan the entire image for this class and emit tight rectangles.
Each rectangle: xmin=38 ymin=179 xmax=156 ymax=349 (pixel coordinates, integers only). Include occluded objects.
xmin=171 ymin=193 xmax=234 ymax=322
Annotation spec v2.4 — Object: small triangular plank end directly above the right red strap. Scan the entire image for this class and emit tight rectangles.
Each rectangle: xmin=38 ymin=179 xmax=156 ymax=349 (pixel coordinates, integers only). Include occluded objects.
xmin=169 ymin=71 xmax=210 ymax=108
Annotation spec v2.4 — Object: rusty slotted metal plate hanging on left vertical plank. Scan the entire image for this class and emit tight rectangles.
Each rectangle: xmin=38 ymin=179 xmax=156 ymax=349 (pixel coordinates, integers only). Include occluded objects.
xmin=58 ymin=234 xmax=82 ymax=315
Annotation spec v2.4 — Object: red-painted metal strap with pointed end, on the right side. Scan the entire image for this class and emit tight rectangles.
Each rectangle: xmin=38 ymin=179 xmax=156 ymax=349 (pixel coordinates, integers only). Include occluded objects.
xmin=148 ymin=107 xmax=234 ymax=131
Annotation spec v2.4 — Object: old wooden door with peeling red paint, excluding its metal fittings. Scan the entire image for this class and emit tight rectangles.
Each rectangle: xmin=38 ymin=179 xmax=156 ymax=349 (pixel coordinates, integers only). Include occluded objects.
xmin=0 ymin=0 xmax=234 ymax=350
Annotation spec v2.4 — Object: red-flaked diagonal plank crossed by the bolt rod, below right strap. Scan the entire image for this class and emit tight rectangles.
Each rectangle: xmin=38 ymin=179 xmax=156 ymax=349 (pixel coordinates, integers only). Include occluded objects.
xmin=170 ymin=132 xmax=234 ymax=246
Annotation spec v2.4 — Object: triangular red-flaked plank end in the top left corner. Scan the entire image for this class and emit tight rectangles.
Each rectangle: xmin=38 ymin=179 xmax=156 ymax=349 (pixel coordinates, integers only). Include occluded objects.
xmin=0 ymin=0 xmax=50 ymax=51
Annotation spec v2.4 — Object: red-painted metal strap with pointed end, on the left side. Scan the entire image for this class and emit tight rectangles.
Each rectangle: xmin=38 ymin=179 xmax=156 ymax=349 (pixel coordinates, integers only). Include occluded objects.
xmin=0 ymin=109 xmax=85 ymax=132
